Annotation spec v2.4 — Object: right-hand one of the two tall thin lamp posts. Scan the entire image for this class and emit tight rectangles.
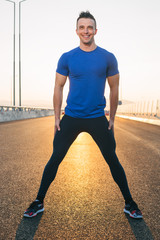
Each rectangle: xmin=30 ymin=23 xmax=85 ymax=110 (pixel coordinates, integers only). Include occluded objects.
xmin=19 ymin=0 xmax=26 ymax=106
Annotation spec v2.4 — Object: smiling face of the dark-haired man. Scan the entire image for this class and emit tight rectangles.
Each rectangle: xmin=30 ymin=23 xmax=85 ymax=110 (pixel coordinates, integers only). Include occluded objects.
xmin=76 ymin=18 xmax=97 ymax=45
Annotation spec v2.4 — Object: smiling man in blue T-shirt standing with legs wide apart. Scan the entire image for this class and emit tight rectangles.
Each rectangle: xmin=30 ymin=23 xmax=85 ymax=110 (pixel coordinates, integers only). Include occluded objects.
xmin=24 ymin=12 xmax=142 ymax=218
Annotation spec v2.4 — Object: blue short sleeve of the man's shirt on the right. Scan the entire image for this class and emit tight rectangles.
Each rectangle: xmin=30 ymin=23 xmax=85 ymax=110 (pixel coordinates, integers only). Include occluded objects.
xmin=107 ymin=53 xmax=119 ymax=77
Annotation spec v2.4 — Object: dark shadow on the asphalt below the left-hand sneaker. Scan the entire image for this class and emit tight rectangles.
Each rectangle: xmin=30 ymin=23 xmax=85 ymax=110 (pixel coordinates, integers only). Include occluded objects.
xmin=15 ymin=212 xmax=43 ymax=240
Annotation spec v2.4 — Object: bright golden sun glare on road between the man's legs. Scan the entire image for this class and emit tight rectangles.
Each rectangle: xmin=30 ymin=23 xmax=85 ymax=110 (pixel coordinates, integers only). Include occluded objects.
xmin=61 ymin=132 xmax=100 ymax=191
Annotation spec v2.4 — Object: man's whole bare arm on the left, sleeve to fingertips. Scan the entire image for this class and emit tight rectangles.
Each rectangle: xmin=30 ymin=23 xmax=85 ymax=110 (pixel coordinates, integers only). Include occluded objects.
xmin=53 ymin=73 xmax=67 ymax=135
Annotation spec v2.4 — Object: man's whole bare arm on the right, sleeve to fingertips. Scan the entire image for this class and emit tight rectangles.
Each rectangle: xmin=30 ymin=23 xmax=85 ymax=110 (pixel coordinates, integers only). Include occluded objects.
xmin=108 ymin=74 xmax=119 ymax=132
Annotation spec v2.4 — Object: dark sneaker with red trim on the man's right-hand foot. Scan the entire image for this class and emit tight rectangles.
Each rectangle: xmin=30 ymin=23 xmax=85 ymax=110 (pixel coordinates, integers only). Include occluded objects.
xmin=124 ymin=201 xmax=143 ymax=219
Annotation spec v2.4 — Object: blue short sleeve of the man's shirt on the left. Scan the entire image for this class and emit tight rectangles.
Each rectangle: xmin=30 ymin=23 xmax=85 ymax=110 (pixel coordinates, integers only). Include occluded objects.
xmin=56 ymin=53 xmax=69 ymax=76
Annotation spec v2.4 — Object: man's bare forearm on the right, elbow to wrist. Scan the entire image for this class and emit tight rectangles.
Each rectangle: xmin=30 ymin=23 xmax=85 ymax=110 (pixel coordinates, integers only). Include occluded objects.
xmin=110 ymin=87 xmax=118 ymax=121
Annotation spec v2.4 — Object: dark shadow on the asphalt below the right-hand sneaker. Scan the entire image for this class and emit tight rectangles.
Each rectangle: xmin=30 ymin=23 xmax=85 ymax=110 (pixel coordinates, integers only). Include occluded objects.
xmin=126 ymin=215 xmax=154 ymax=240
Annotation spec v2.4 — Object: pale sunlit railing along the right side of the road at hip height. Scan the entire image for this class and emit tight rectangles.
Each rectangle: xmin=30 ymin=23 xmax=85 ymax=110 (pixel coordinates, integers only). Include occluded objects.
xmin=117 ymin=100 xmax=160 ymax=119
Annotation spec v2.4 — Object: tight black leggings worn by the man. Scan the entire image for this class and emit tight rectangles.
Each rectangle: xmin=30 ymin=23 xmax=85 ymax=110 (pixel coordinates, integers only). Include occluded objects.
xmin=37 ymin=115 xmax=132 ymax=202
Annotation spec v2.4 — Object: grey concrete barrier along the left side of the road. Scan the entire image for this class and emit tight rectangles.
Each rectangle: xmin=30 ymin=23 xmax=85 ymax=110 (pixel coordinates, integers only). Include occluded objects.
xmin=0 ymin=106 xmax=54 ymax=122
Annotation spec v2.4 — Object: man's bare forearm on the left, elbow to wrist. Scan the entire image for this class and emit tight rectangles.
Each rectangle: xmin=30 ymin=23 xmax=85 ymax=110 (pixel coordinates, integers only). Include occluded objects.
xmin=53 ymin=86 xmax=63 ymax=120
